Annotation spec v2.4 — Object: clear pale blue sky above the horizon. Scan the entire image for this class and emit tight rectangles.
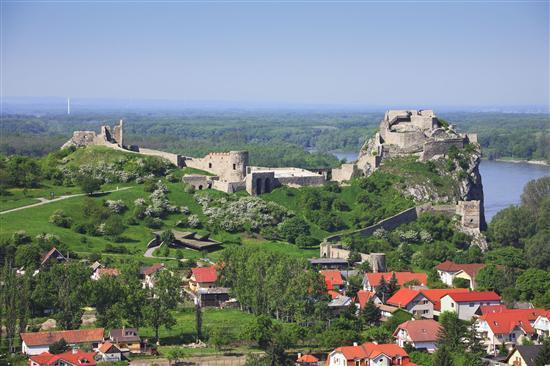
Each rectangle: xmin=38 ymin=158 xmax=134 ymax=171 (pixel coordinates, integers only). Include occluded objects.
xmin=1 ymin=0 xmax=550 ymax=106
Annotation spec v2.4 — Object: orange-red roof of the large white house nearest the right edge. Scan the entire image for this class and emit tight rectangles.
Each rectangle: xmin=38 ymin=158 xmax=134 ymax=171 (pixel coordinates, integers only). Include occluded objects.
xmin=479 ymin=309 xmax=546 ymax=334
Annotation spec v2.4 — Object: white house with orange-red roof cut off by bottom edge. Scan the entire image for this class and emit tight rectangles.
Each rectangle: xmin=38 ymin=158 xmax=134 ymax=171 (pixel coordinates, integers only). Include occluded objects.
xmin=326 ymin=342 xmax=415 ymax=366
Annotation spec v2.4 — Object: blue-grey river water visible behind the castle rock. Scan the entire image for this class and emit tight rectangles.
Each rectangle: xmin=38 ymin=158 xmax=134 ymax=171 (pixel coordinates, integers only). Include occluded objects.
xmin=334 ymin=152 xmax=550 ymax=222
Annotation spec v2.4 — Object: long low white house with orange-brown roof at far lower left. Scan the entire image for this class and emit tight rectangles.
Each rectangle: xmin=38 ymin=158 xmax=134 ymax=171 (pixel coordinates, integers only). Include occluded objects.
xmin=21 ymin=328 xmax=104 ymax=356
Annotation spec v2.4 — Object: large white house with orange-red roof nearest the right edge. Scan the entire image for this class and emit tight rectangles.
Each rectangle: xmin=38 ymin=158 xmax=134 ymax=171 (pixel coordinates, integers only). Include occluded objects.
xmin=475 ymin=309 xmax=545 ymax=354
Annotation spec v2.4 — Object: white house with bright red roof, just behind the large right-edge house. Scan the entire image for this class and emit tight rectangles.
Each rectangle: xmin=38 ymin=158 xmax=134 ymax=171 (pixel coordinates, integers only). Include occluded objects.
xmin=441 ymin=291 xmax=500 ymax=321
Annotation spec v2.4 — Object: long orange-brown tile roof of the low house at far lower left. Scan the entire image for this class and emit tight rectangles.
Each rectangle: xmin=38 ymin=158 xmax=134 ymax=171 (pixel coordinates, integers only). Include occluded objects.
xmin=21 ymin=328 xmax=103 ymax=347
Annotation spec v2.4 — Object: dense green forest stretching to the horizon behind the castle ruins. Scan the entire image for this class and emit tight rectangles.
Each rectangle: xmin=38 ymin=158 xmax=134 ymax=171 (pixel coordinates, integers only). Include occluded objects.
xmin=0 ymin=111 xmax=550 ymax=163
